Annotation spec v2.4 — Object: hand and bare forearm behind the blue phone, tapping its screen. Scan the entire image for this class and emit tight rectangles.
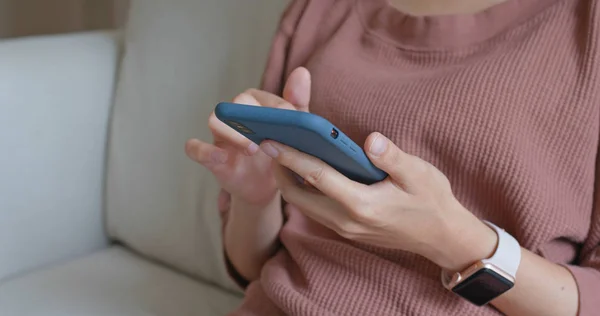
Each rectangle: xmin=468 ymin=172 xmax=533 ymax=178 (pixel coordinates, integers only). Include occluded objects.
xmin=186 ymin=68 xmax=311 ymax=282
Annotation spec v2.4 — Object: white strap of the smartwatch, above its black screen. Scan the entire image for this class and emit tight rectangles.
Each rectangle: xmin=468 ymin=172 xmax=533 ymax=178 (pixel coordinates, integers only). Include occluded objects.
xmin=482 ymin=221 xmax=521 ymax=277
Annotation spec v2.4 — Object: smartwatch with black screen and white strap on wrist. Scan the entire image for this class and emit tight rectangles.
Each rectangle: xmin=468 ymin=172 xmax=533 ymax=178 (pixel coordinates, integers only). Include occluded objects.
xmin=442 ymin=221 xmax=521 ymax=306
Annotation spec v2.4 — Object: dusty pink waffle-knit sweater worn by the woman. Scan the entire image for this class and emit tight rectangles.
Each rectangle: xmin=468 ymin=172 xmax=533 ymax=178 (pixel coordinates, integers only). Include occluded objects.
xmin=224 ymin=0 xmax=600 ymax=316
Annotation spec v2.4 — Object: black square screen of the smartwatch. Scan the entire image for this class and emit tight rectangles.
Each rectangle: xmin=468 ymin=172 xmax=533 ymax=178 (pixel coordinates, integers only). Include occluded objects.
xmin=452 ymin=268 xmax=514 ymax=306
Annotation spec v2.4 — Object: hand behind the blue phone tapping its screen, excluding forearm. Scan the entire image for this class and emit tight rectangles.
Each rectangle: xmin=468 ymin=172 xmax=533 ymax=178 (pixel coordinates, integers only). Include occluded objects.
xmin=185 ymin=68 xmax=310 ymax=206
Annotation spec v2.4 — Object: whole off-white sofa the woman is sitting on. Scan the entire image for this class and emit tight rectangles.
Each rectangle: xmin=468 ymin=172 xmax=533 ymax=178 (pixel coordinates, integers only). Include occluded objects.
xmin=0 ymin=0 xmax=286 ymax=316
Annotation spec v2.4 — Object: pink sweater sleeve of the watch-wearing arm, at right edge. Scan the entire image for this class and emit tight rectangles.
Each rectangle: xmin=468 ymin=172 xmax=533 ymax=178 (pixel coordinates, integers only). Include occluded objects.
xmin=567 ymin=173 xmax=600 ymax=316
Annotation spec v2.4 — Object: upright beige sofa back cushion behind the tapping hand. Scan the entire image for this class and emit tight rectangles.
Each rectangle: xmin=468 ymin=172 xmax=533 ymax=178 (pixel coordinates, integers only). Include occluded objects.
xmin=106 ymin=0 xmax=287 ymax=289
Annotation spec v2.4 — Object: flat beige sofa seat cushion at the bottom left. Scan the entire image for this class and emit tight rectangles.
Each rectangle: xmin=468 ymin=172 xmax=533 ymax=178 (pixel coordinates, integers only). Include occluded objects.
xmin=0 ymin=247 xmax=240 ymax=316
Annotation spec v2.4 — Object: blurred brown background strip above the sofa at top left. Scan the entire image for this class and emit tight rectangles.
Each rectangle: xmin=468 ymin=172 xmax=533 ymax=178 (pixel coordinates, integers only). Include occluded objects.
xmin=0 ymin=0 xmax=129 ymax=38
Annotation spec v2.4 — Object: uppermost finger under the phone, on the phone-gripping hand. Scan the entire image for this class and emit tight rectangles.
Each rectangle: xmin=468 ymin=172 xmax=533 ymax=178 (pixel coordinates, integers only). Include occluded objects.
xmin=260 ymin=141 xmax=367 ymax=206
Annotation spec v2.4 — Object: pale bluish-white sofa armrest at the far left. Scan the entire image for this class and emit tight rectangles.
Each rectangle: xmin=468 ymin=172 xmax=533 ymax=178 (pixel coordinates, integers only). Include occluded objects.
xmin=0 ymin=32 xmax=120 ymax=283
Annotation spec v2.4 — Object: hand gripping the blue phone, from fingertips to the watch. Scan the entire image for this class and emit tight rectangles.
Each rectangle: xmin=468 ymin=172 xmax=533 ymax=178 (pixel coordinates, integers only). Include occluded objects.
xmin=261 ymin=133 xmax=497 ymax=271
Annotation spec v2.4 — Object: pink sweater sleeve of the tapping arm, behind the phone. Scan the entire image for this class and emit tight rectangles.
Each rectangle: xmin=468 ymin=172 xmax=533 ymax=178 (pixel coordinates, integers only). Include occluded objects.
xmin=219 ymin=0 xmax=308 ymax=289
